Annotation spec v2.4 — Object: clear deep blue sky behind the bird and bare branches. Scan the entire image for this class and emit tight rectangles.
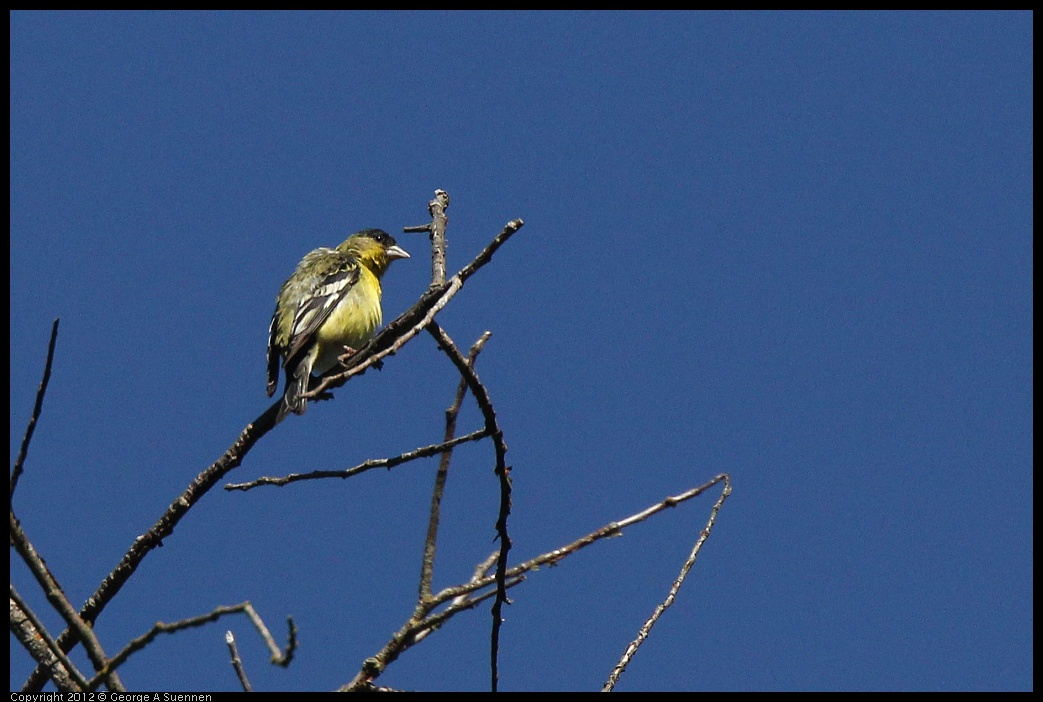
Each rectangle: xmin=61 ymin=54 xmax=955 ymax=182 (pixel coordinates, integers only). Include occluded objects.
xmin=10 ymin=13 xmax=1033 ymax=692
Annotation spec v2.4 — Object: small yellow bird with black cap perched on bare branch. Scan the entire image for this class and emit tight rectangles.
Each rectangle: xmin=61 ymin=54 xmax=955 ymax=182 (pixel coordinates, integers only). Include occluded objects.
xmin=267 ymin=228 xmax=410 ymax=423
